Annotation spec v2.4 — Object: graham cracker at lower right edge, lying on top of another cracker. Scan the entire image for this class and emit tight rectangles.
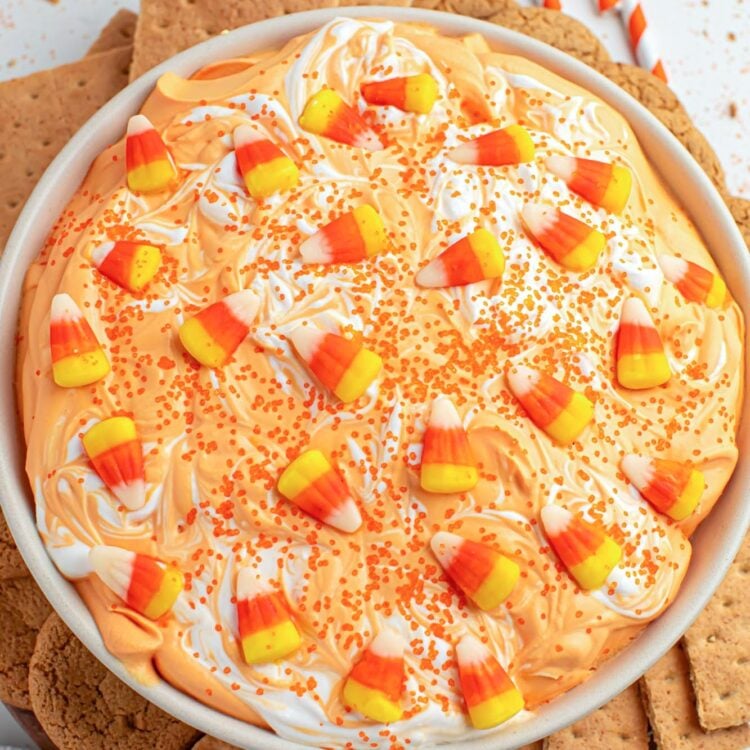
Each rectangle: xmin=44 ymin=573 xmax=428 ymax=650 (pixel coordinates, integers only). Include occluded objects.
xmin=684 ymin=537 xmax=750 ymax=730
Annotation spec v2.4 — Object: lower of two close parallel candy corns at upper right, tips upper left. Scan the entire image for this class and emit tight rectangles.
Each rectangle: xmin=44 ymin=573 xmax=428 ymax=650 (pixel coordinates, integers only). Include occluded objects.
xmin=523 ymin=203 xmax=607 ymax=271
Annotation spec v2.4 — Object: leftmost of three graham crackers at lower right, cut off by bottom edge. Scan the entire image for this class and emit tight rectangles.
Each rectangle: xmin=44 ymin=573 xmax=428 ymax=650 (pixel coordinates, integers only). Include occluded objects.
xmin=543 ymin=684 xmax=649 ymax=750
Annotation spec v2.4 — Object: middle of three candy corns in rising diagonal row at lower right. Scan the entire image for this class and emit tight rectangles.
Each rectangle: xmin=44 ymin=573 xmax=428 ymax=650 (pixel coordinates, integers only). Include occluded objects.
xmin=542 ymin=505 xmax=622 ymax=590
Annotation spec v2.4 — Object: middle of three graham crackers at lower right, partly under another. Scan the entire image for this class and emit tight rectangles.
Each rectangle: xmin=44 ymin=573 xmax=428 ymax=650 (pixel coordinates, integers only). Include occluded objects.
xmin=641 ymin=645 xmax=750 ymax=750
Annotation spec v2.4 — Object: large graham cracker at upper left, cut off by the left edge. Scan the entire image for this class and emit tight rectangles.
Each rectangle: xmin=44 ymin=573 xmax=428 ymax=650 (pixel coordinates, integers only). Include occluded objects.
xmin=0 ymin=47 xmax=132 ymax=250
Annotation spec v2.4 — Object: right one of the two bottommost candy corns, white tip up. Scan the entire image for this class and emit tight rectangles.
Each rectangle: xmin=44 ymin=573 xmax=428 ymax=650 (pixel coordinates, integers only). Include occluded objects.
xmin=456 ymin=635 xmax=524 ymax=729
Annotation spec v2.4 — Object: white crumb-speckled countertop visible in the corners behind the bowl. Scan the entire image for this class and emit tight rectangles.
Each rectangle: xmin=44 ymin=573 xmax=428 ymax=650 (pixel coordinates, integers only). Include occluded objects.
xmin=0 ymin=0 xmax=750 ymax=748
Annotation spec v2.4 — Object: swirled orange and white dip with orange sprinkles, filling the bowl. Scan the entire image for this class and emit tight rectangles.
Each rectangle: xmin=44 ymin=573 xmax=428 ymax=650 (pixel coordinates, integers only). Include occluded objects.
xmin=19 ymin=19 xmax=744 ymax=747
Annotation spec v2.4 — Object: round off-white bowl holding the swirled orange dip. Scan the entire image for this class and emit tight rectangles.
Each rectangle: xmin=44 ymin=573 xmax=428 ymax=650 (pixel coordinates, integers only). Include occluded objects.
xmin=0 ymin=7 xmax=750 ymax=750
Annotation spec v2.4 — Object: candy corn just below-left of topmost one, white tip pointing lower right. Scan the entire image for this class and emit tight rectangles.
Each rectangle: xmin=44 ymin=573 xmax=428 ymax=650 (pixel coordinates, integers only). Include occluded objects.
xmin=299 ymin=89 xmax=383 ymax=151
